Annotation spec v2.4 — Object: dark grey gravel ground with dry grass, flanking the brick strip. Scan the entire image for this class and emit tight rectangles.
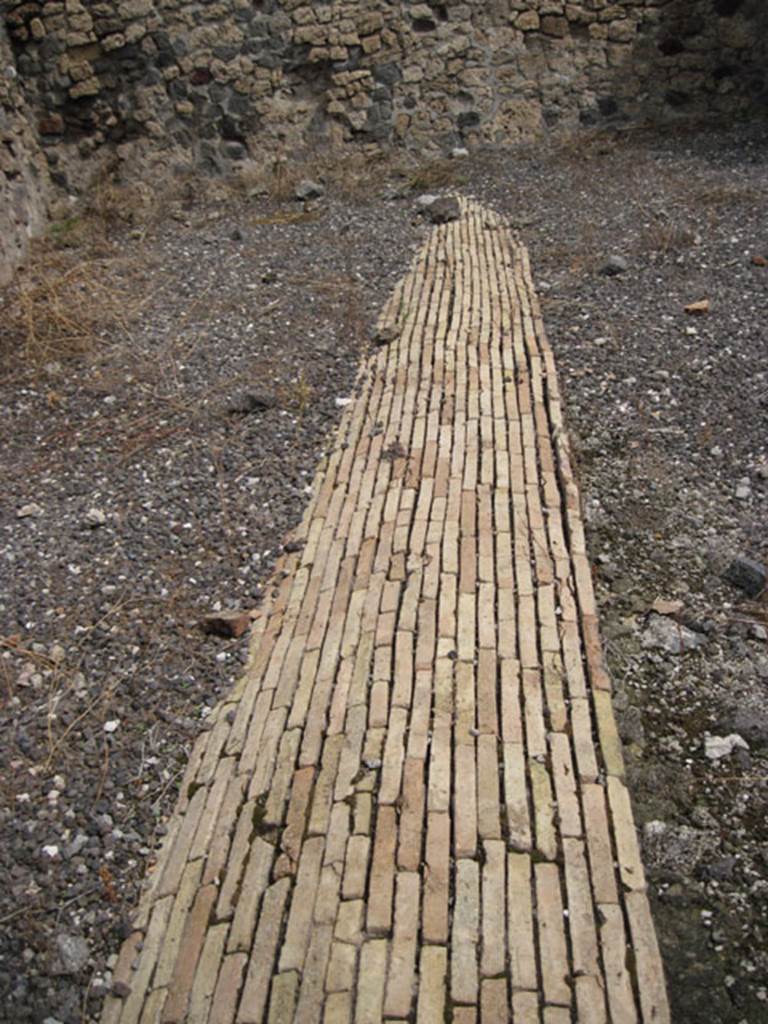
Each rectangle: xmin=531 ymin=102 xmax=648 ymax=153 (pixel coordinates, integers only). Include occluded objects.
xmin=0 ymin=129 xmax=768 ymax=1024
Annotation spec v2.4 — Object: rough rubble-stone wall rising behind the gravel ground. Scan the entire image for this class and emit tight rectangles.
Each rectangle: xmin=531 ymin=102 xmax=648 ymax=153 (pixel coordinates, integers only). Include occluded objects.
xmin=0 ymin=0 xmax=768 ymax=280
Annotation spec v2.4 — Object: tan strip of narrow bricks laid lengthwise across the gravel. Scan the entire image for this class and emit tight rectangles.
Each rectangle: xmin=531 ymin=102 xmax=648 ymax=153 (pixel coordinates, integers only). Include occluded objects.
xmin=103 ymin=203 xmax=669 ymax=1024
